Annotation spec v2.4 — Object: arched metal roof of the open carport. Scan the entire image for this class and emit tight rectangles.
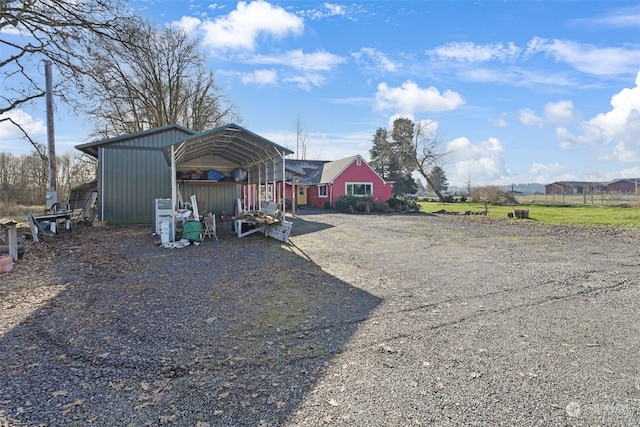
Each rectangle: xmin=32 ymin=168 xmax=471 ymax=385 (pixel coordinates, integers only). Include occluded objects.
xmin=162 ymin=123 xmax=293 ymax=168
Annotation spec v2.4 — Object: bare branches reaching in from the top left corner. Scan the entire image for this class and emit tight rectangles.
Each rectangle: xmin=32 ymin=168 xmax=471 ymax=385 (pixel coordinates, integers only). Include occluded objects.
xmin=0 ymin=0 xmax=133 ymax=149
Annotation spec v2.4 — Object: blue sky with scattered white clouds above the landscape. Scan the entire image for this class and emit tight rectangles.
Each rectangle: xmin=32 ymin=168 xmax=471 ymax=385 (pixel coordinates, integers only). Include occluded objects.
xmin=0 ymin=0 xmax=640 ymax=187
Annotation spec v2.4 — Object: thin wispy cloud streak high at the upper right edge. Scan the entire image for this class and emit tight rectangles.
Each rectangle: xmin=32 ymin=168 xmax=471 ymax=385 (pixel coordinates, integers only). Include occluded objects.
xmin=526 ymin=37 xmax=640 ymax=76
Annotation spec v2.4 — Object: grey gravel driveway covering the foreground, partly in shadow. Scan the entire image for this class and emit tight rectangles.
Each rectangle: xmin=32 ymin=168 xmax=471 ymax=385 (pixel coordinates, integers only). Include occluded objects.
xmin=0 ymin=211 xmax=640 ymax=427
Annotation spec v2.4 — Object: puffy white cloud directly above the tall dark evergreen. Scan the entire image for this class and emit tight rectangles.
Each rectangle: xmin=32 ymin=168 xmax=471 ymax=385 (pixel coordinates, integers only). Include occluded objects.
xmin=374 ymin=81 xmax=464 ymax=116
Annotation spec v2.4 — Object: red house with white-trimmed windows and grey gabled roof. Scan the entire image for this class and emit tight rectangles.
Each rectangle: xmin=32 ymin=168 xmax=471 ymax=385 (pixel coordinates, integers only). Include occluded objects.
xmin=285 ymin=155 xmax=393 ymax=208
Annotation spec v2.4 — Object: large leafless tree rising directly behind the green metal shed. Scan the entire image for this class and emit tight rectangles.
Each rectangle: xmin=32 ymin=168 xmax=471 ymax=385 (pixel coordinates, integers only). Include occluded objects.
xmin=83 ymin=22 xmax=237 ymax=138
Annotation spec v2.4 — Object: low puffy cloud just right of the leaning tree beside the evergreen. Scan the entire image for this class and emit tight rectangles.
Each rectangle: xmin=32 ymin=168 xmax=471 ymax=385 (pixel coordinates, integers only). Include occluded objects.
xmin=445 ymin=137 xmax=512 ymax=186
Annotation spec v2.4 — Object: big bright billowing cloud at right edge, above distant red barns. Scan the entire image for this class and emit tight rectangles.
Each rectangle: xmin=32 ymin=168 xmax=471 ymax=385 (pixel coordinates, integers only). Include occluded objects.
xmin=557 ymin=72 xmax=640 ymax=162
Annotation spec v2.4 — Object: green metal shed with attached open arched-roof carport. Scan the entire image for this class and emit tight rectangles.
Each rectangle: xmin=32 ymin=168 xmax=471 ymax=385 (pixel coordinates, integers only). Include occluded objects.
xmin=76 ymin=124 xmax=293 ymax=224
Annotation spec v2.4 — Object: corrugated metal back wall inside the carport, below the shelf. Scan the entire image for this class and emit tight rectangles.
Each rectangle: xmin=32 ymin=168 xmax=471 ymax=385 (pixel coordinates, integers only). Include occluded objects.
xmin=179 ymin=183 xmax=242 ymax=218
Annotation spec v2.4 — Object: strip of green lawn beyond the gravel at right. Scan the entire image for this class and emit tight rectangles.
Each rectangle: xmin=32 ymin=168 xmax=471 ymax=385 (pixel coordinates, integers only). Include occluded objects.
xmin=418 ymin=202 xmax=640 ymax=227
